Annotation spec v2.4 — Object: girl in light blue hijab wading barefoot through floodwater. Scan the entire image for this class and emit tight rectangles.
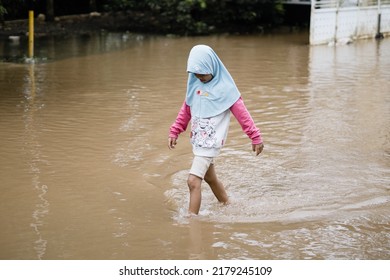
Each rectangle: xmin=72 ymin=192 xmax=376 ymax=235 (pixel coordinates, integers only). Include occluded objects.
xmin=168 ymin=45 xmax=264 ymax=215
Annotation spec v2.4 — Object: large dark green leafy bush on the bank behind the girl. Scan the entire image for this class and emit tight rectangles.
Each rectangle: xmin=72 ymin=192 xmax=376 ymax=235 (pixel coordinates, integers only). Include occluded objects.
xmin=105 ymin=0 xmax=283 ymax=34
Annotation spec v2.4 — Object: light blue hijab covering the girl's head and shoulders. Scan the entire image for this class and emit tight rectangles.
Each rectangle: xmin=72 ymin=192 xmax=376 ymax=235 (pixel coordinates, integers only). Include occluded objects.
xmin=186 ymin=45 xmax=241 ymax=118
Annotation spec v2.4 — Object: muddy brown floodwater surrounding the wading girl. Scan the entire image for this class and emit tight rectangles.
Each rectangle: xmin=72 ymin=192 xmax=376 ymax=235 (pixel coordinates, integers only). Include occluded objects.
xmin=0 ymin=32 xmax=390 ymax=259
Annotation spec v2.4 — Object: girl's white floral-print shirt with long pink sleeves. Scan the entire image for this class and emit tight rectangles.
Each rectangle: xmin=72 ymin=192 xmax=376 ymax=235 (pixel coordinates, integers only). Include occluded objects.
xmin=169 ymin=97 xmax=263 ymax=156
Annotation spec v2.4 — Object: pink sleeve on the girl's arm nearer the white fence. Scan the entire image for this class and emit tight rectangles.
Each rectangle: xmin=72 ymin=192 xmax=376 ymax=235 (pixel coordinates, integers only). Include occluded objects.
xmin=230 ymin=97 xmax=263 ymax=145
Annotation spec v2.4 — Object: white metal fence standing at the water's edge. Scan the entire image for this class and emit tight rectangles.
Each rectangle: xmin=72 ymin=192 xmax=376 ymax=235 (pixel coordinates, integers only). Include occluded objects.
xmin=310 ymin=0 xmax=390 ymax=45
